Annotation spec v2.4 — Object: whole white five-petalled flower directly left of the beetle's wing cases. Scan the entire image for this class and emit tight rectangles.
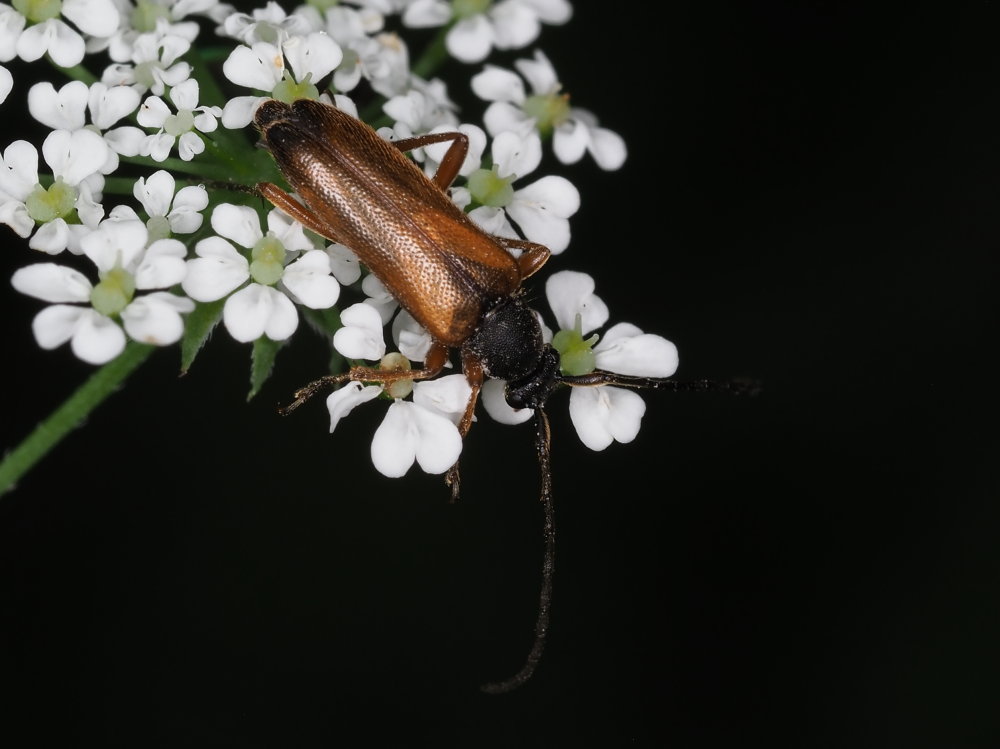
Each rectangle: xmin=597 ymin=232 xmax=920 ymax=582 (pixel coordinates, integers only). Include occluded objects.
xmin=183 ymin=203 xmax=340 ymax=343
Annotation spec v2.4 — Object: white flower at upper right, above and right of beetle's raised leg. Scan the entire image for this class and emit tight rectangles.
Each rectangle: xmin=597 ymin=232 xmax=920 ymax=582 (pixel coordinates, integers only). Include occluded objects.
xmin=472 ymin=50 xmax=627 ymax=170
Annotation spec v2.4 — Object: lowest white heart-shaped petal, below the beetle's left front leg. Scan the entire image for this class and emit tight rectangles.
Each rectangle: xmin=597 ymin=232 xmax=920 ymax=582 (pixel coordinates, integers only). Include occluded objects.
xmin=371 ymin=401 xmax=462 ymax=478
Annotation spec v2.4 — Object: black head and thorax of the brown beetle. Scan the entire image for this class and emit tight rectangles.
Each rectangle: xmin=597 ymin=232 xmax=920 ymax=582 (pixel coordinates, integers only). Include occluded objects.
xmin=462 ymin=297 xmax=559 ymax=408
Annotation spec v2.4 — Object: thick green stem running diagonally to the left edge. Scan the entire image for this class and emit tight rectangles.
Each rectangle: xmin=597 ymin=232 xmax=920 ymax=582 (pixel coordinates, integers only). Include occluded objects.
xmin=0 ymin=341 xmax=154 ymax=495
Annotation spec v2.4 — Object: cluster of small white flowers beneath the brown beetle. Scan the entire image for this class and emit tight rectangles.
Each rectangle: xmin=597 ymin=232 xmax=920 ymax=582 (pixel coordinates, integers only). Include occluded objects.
xmin=0 ymin=0 xmax=677 ymax=486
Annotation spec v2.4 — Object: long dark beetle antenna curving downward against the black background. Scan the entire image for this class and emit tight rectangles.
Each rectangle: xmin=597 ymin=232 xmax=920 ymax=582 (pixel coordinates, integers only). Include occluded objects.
xmin=480 ymin=406 xmax=556 ymax=694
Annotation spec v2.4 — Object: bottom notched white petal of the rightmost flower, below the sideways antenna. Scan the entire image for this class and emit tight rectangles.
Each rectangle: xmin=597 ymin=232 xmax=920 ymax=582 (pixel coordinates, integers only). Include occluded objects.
xmin=569 ymin=385 xmax=646 ymax=450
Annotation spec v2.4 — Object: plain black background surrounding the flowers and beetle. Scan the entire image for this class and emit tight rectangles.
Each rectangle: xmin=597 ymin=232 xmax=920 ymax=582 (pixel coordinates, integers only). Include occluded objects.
xmin=0 ymin=2 xmax=1000 ymax=747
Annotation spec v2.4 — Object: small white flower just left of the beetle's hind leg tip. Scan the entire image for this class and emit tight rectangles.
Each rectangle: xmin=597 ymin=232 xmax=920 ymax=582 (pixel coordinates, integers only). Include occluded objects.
xmin=110 ymin=169 xmax=208 ymax=239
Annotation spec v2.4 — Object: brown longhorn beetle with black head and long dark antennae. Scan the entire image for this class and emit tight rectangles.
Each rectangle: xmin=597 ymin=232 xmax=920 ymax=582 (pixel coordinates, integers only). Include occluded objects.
xmin=254 ymin=99 xmax=752 ymax=693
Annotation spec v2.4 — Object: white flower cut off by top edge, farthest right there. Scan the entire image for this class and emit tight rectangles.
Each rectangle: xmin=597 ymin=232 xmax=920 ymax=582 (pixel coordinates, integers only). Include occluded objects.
xmin=403 ymin=0 xmax=572 ymax=62
